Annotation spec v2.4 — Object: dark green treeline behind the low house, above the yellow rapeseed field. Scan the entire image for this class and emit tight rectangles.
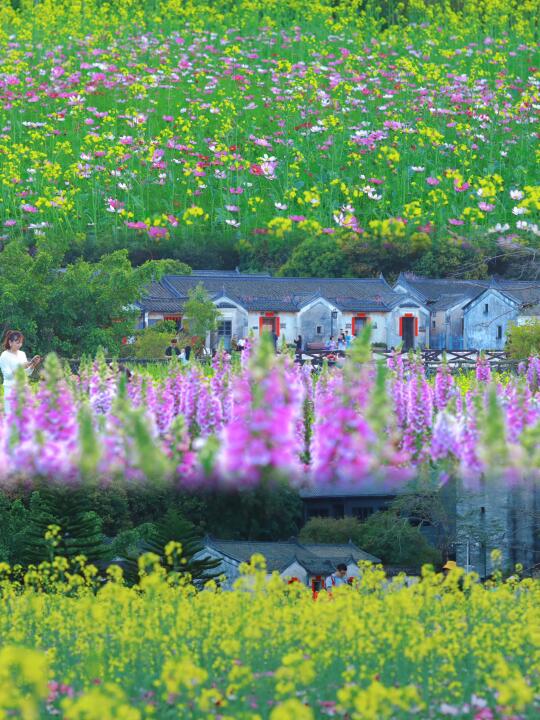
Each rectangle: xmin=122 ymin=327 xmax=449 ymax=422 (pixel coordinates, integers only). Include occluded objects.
xmin=0 ymin=485 xmax=441 ymax=579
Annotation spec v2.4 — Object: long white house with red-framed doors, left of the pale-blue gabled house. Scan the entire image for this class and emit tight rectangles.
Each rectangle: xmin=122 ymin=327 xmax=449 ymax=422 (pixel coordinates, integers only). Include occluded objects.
xmin=138 ymin=270 xmax=429 ymax=349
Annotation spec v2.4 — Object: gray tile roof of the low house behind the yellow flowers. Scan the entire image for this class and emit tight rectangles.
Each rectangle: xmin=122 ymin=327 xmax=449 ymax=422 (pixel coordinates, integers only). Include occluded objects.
xmin=204 ymin=537 xmax=380 ymax=574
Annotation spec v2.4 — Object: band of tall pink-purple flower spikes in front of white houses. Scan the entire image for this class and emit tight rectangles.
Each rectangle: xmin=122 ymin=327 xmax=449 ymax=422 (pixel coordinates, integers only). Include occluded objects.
xmin=0 ymin=342 xmax=540 ymax=489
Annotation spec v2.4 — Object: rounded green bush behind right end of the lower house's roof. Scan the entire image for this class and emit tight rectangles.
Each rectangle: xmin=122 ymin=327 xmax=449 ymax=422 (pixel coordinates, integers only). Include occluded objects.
xmin=300 ymin=510 xmax=441 ymax=568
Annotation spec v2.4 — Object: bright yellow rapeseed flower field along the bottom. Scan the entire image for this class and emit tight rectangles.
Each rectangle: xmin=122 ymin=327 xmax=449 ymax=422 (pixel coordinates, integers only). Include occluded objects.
xmin=0 ymin=560 xmax=540 ymax=720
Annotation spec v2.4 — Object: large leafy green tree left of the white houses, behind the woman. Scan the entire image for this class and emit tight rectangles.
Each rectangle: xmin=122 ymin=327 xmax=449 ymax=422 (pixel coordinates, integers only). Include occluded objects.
xmin=0 ymin=239 xmax=190 ymax=356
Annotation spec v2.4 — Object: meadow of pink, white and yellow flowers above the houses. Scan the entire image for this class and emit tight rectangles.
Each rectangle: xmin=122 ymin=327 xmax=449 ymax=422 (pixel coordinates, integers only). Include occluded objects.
xmin=0 ymin=0 xmax=540 ymax=272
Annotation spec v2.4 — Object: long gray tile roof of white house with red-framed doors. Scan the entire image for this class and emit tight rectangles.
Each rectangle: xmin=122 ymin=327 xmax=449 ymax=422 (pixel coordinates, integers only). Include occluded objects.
xmin=138 ymin=271 xmax=412 ymax=312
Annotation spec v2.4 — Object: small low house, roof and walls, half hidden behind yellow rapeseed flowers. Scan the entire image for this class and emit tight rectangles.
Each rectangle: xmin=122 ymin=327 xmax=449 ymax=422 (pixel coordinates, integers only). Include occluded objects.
xmin=195 ymin=536 xmax=380 ymax=590
